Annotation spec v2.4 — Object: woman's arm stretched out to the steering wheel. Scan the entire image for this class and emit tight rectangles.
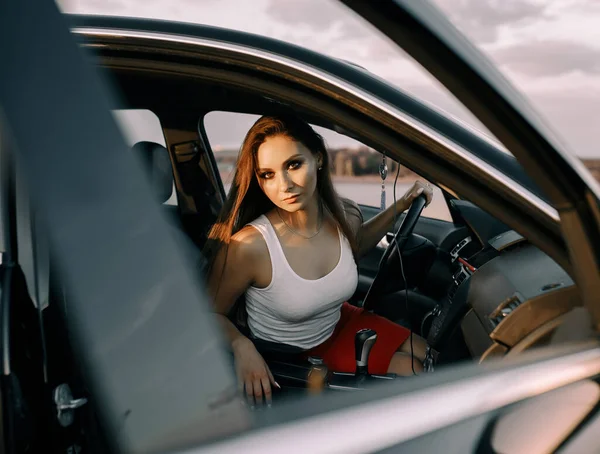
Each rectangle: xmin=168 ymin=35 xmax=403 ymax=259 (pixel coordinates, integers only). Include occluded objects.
xmin=358 ymin=181 xmax=433 ymax=257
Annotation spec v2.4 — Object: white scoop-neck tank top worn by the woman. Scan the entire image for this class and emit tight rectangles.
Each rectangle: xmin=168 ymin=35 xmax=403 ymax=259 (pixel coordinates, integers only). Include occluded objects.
xmin=246 ymin=215 xmax=358 ymax=349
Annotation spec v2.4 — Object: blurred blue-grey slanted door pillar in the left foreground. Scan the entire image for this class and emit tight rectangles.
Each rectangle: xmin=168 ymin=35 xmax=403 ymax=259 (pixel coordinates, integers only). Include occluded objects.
xmin=0 ymin=1 xmax=248 ymax=452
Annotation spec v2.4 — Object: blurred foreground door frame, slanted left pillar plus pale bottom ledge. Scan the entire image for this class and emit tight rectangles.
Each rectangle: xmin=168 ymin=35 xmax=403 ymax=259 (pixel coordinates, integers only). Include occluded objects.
xmin=0 ymin=1 xmax=600 ymax=453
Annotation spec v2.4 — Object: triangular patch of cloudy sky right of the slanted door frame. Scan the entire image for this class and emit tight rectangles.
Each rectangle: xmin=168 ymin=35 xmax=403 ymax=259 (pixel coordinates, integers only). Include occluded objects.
xmin=434 ymin=0 xmax=600 ymax=169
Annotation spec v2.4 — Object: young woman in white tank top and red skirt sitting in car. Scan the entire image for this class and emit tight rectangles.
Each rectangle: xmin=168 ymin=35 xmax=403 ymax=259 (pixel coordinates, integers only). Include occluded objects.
xmin=207 ymin=116 xmax=433 ymax=401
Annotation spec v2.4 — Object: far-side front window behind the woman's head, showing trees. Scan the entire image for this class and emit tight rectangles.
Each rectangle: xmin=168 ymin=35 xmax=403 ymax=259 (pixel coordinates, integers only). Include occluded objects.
xmin=204 ymin=112 xmax=451 ymax=221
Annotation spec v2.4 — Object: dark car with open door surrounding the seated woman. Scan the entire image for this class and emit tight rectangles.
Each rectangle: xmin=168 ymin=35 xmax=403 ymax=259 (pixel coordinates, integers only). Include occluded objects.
xmin=0 ymin=0 xmax=600 ymax=453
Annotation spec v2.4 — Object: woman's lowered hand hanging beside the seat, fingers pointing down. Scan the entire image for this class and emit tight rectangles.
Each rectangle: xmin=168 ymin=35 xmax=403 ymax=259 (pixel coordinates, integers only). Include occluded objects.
xmin=232 ymin=337 xmax=281 ymax=407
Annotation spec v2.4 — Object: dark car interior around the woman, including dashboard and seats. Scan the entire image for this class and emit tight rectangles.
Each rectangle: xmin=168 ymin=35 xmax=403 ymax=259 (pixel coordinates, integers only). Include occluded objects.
xmin=102 ymin=71 xmax=580 ymax=389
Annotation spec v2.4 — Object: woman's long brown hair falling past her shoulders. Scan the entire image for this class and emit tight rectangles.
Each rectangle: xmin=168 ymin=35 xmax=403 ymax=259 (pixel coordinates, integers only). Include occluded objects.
xmin=204 ymin=114 xmax=358 ymax=272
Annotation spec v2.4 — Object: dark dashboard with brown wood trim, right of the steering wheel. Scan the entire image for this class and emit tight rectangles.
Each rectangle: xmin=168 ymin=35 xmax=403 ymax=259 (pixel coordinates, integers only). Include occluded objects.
xmin=427 ymin=201 xmax=581 ymax=361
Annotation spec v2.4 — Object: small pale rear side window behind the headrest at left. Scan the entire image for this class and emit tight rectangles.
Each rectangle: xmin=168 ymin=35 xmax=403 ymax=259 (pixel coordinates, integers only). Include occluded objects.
xmin=113 ymin=109 xmax=177 ymax=205
